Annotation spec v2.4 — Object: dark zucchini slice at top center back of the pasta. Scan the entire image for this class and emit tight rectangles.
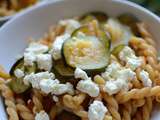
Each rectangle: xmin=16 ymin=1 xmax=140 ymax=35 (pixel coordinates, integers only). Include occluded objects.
xmin=80 ymin=11 xmax=108 ymax=23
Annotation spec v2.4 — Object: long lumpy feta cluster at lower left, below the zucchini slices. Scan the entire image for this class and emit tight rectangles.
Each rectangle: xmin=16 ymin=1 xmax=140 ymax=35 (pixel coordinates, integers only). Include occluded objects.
xmin=23 ymin=71 xmax=74 ymax=95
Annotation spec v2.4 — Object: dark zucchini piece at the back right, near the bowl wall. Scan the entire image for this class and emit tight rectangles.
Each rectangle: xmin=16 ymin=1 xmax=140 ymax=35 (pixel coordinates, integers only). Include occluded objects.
xmin=118 ymin=13 xmax=140 ymax=36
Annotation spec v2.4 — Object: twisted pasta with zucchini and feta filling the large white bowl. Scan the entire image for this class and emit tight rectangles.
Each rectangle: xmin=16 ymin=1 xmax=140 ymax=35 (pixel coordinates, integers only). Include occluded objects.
xmin=0 ymin=12 xmax=160 ymax=120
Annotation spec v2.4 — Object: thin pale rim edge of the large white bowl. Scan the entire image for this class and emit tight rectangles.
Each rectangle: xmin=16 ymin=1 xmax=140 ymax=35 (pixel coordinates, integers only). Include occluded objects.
xmin=0 ymin=0 xmax=160 ymax=29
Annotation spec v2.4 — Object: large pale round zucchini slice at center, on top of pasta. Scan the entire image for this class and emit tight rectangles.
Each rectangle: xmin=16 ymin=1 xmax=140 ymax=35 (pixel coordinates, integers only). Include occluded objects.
xmin=63 ymin=36 xmax=109 ymax=70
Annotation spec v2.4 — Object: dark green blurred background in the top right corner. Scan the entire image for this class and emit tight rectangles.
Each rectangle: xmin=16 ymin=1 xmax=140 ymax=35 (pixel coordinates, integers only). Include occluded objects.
xmin=129 ymin=0 xmax=160 ymax=16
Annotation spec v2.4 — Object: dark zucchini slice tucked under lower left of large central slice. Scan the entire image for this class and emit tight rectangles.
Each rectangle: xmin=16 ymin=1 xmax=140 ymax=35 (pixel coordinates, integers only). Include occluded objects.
xmin=53 ymin=59 xmax=74 ymax=78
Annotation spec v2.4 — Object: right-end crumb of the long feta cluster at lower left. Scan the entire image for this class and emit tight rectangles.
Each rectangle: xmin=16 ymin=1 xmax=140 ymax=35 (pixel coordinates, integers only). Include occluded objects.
xmin=52 ymin=83 xmax=74 ymax=95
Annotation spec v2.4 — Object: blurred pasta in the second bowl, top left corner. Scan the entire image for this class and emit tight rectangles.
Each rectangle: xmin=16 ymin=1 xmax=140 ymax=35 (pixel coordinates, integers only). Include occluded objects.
xmin=0 ymin=0 xmax=38 ymax=17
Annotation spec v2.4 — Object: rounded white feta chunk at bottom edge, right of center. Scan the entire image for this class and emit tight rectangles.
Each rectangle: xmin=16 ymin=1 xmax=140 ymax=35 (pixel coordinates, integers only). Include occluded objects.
xmin=88 ymin=100 xmax=108 ymax=120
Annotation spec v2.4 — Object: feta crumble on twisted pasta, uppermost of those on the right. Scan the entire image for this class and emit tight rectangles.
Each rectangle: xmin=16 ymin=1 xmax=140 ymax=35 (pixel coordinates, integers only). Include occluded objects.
xmin=119 ymin=46 xmax=142 ymax=70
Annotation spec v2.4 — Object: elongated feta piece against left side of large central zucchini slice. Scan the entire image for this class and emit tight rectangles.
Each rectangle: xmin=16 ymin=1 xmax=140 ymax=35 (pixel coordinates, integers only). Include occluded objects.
xmin=50 ymin=33 xmax=70 ymax=60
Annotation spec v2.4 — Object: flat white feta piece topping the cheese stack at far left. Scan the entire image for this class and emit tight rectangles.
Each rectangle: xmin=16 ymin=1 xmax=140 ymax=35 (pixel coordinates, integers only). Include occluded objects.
xmin=25 ymin=42 xmax=48 ymax=54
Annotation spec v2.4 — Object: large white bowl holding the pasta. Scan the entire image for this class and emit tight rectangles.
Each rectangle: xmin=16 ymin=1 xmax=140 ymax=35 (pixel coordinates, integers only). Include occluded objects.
xmin=0 ymin=0 xmax=160 ymax=120
